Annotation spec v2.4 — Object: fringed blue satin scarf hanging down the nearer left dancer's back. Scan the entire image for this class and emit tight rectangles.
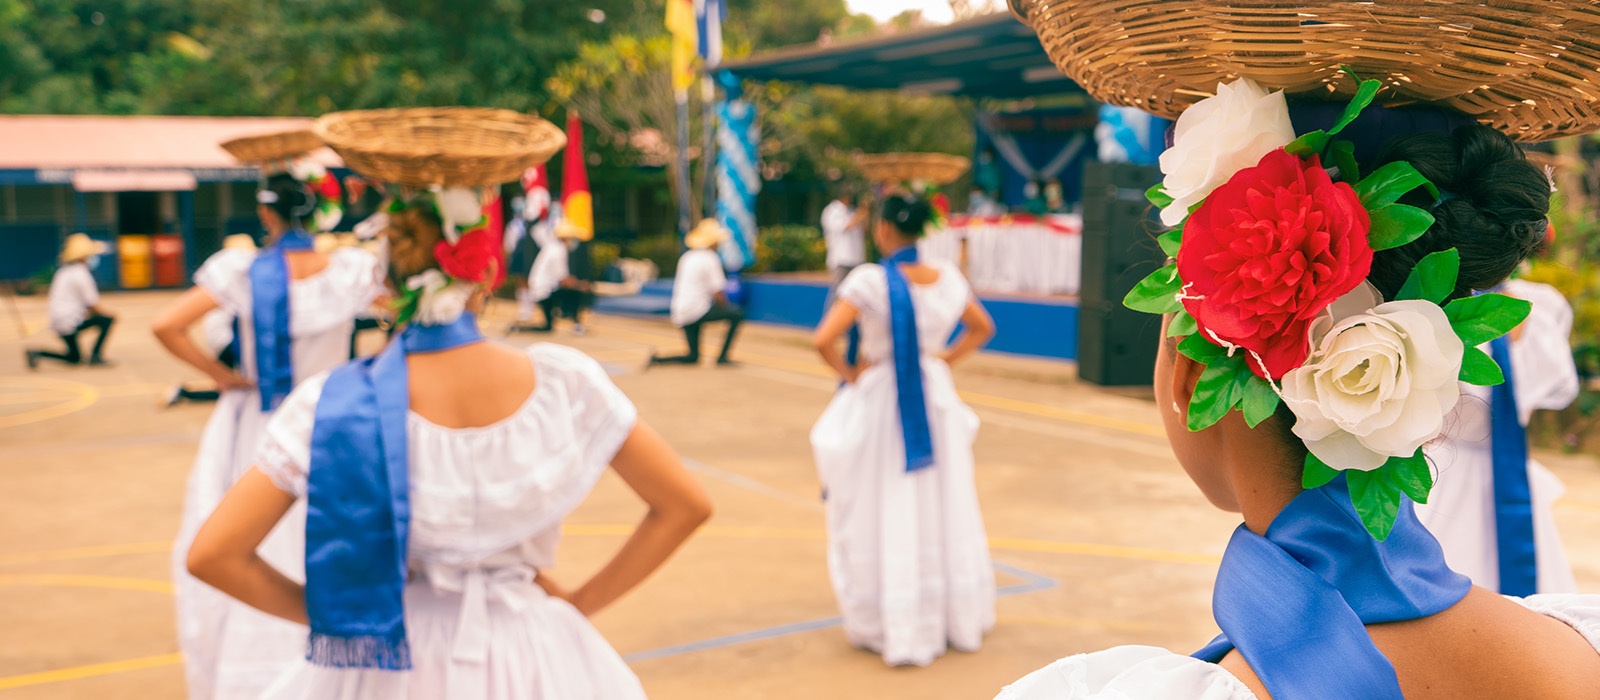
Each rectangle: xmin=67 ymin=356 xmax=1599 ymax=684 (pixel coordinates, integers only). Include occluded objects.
xmin=306 ymin=313 xmax=483 ymax=671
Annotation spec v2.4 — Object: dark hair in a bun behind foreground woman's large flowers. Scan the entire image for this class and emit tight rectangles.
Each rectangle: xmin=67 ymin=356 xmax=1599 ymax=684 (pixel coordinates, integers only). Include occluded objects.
xmin=1366 ymin=125 xmax=1550 ymax=299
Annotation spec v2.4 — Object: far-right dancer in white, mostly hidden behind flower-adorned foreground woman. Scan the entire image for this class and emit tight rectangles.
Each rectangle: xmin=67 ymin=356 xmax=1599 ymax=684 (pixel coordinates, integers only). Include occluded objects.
xmin=1416 ymin=280 xmax=1578 ymax=596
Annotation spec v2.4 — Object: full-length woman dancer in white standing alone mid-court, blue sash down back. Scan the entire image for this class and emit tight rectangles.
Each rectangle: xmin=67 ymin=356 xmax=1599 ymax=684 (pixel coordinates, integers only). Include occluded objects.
xmin=811 ymin=195 xmax=995 ymax=666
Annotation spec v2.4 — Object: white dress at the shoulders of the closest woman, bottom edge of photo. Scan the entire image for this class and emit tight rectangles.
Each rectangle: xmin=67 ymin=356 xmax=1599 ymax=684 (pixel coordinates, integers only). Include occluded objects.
xmin=995 ymin=595 xmax=1600 ymax=700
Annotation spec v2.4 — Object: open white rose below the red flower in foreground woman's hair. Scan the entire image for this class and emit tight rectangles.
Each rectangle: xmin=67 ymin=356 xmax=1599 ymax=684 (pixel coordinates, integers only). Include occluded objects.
xmin=1283 ymin=297 xmax=1466 ymax=471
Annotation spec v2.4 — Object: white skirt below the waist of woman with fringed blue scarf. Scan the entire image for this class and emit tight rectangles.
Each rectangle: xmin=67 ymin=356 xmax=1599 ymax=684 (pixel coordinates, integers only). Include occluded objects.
xmin=262 ymin=582 xmax=645 ymax=700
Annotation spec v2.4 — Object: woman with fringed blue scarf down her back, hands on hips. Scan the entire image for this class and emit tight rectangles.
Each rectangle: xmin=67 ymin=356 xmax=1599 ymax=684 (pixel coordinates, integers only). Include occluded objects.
xmin=189 ymin=190 xmax=710 ymax=700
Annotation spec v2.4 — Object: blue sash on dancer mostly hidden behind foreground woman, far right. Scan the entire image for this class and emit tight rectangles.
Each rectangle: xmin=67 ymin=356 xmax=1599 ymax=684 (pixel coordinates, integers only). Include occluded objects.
xmin=1490 ymin=336 xmax=1539 ymax=596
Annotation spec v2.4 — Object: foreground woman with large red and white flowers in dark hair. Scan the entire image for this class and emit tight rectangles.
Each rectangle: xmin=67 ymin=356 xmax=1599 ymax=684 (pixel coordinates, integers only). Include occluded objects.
xmin=1000 ymin=80 xmax=1600 ymax=700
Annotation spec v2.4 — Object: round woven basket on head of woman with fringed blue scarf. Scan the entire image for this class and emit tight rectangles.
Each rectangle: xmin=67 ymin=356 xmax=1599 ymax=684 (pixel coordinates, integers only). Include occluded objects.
xmin=314 ymin=107 xmax=566 ymax=187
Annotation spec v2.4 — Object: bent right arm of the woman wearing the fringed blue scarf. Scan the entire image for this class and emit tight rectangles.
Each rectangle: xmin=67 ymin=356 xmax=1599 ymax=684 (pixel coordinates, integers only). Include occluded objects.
xmin=550 ymin=422 xmax=710 ymax=615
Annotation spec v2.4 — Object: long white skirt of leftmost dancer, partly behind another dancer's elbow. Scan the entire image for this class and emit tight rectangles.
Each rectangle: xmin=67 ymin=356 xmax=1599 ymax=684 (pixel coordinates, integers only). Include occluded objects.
xmin=173 ymin=392 xmax=309 ymax=700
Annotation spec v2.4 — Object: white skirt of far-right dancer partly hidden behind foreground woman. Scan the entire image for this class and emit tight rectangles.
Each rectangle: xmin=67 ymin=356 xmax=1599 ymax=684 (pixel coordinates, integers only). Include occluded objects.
xmin=1416 ymin=446 xmax=1578 ymax=593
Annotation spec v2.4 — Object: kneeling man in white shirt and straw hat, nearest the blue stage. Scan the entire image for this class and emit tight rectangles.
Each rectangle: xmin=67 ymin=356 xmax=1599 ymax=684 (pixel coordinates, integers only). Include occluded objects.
xmin=650 ymin=219 xmax=744 ymax=366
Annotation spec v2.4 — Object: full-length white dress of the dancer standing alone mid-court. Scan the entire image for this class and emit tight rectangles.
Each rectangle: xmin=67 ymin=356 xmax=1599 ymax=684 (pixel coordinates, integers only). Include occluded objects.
xmin=811 ymin=264 xmax=995 ymax=665
